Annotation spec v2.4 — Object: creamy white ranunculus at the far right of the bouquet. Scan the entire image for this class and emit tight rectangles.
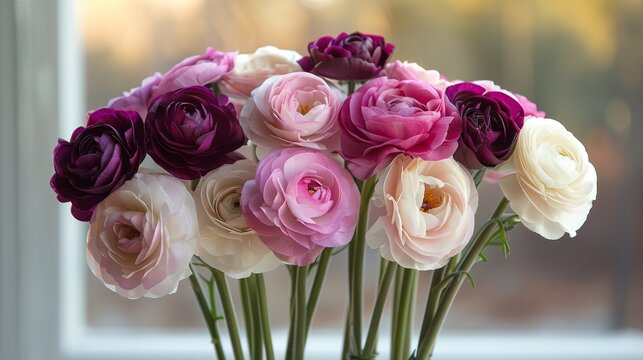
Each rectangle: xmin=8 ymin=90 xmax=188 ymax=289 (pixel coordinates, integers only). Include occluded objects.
xmin=498 ymin=118 xmax=596 ymax=239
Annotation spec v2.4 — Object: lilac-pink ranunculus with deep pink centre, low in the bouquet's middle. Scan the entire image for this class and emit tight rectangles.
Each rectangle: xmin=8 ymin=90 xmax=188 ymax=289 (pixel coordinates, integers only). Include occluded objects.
xmin=241 ymin=148 xmax=359 ymax=265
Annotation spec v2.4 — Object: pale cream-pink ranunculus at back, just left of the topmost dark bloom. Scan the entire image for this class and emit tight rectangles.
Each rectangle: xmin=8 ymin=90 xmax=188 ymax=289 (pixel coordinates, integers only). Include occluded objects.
xmin=220 ymin=46 xmax=301 ymax=100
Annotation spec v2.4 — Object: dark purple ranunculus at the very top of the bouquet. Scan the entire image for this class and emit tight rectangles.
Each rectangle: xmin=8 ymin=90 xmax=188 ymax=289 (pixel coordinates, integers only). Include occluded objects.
xmin=297 ymin=32 xmax=395 ymax=80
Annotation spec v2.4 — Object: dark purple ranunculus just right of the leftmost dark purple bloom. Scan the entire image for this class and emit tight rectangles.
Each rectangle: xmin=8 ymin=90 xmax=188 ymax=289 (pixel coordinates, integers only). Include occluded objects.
xmin=145 ymin=86 xmax=246 ymax=180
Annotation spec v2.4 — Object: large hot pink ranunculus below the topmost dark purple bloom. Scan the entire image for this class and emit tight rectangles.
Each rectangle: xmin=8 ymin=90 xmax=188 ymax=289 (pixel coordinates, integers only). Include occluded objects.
xmin=338 ymin=77 xmax=462 ymax=179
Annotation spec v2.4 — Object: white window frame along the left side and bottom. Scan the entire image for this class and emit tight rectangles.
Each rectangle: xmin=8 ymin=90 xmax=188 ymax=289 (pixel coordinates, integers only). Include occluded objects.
xmin=0 ymin=0 xmax=643 ymax=360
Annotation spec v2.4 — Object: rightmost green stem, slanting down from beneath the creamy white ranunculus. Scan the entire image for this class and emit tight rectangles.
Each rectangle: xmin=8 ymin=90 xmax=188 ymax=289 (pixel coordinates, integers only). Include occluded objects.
xmin=417 ymin=197 xmax=509 ymax=360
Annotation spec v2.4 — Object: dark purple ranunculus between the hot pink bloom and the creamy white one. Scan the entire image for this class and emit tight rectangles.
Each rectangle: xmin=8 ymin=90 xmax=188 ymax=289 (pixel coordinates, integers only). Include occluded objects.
xmin=446 ymin=82 xmax=525 ymax=169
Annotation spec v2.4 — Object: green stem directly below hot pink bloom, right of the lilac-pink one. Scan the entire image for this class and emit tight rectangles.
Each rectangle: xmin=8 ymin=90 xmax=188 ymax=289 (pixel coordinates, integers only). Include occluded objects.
xmin=351 ymin=176 xmax=377 ymax=354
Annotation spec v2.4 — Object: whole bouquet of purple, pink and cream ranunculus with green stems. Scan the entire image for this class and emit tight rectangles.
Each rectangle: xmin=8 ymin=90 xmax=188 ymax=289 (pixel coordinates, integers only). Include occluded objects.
xmin=51 ymin=32 xmax=596 ymax=360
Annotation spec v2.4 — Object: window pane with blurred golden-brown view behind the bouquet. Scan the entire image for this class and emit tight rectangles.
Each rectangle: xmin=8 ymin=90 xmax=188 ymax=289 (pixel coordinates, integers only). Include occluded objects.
xmin=83 ymin=0 xmax=643 ymax=332
